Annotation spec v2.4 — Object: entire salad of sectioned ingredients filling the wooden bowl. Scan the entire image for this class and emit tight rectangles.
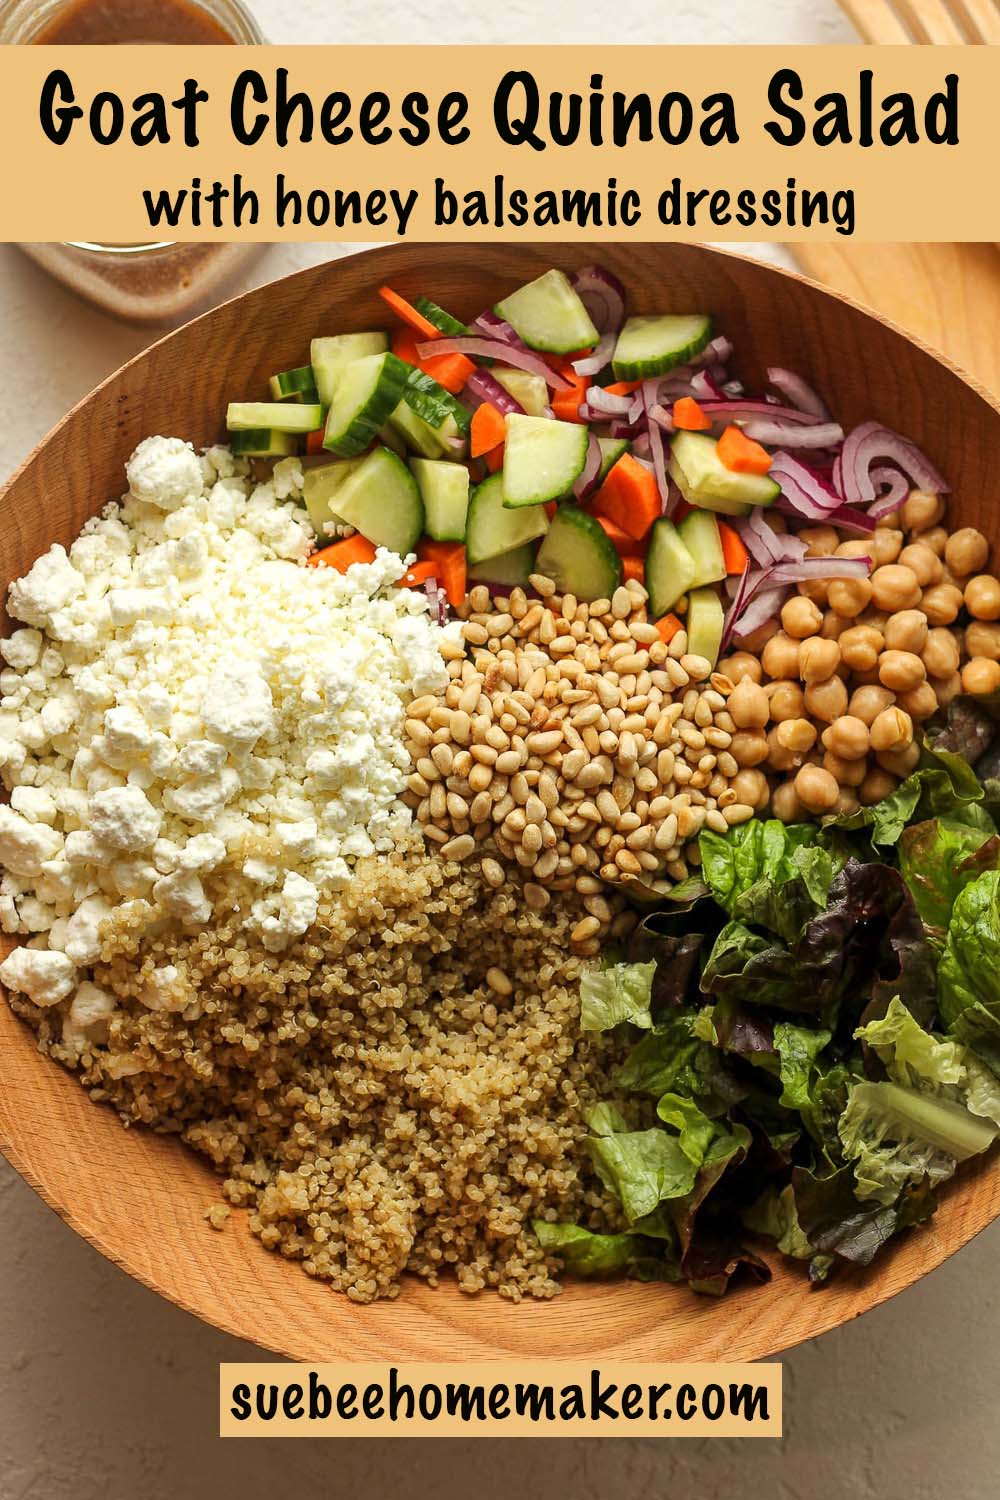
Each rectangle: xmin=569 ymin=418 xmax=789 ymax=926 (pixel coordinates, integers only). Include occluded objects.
xmin=0 ymin=267 xmax=1000 ymax=1302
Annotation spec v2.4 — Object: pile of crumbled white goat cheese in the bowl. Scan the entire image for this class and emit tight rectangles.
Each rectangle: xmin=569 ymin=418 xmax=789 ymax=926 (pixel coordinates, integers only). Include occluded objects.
xmin=0 ymin=437 xmax=457 ymax=1026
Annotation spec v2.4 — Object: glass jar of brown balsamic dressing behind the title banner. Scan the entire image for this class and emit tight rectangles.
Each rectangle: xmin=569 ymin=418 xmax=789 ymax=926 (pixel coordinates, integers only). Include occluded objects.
xmin=0 ymin=0 xmax=264 ymax=323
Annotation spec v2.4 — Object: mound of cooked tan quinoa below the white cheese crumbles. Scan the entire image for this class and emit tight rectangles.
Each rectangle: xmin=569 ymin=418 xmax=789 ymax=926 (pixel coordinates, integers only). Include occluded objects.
xmin=15 ymin=852 xmax=615 ymax=1302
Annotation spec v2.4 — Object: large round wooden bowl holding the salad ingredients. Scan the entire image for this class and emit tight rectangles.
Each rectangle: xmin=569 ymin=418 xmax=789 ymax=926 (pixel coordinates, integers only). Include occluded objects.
xmin=0 ymin=245 xmax=1000 ymax=1359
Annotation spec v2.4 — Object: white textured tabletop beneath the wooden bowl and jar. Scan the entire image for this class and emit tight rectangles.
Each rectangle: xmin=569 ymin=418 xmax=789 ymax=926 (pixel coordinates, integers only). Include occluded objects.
xmin=0 ymin=0 xmax=1000 ymax=1500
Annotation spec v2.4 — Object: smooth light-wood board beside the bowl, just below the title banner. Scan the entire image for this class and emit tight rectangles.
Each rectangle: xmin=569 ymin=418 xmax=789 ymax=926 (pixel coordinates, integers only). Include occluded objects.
xmin=790 ymin=245 xmax=1000 ymax=393
